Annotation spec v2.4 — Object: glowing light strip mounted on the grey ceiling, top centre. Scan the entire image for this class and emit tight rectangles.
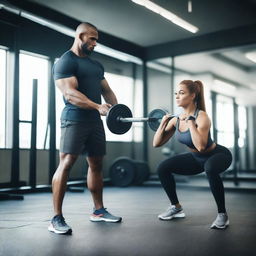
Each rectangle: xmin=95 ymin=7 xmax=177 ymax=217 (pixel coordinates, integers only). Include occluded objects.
xmin=132 ymin=0 xmax=199 ymax=33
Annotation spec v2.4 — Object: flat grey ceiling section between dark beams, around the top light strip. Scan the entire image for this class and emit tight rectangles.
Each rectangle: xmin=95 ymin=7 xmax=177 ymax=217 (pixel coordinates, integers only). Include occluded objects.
xmin=26 ymin=0 xmax=256 ymax=47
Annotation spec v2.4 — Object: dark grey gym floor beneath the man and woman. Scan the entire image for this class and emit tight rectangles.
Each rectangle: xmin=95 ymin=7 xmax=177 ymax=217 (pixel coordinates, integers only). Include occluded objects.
xmin=0 ymin=185 xmax=256 ymax=256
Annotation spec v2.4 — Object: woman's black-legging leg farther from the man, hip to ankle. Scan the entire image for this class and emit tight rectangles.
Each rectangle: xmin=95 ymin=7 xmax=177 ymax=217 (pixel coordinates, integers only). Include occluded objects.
xmin=204 ymin=146 xmax=232 ymax=213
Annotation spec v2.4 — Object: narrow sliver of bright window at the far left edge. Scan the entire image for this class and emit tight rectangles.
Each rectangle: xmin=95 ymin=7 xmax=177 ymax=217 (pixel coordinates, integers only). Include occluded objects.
xmin=0 ymin=49 xmax=6 ymax=148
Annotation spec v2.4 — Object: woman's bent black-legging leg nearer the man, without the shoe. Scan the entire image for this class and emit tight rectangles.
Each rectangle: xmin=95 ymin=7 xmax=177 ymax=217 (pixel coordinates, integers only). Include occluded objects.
xmin=157 ymin=153 xmax=203 ymax=205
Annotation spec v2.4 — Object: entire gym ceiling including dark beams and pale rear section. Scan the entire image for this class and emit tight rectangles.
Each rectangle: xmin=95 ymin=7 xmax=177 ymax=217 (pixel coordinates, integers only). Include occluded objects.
xmin=0 ymin=0 xmax=256 ymax=103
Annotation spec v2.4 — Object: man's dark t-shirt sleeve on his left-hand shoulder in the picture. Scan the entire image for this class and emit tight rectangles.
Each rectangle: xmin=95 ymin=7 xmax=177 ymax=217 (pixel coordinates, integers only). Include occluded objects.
xmin=53 ymin=57 xmax=77 ymax=80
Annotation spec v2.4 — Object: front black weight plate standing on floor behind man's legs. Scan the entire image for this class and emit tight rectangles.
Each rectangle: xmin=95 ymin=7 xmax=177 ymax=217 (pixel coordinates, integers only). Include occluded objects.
xmin=109 ymin=157 xmax=136 ymax=187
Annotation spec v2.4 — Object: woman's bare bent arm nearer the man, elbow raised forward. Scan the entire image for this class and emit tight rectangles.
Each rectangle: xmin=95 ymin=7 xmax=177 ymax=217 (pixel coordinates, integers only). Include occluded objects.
xmin=153 ymin=115 xmax=177 ymax=147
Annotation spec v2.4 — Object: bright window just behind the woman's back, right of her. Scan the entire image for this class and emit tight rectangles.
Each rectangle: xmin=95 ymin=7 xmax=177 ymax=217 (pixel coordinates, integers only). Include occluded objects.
xmin=216 ymin=95 xmax=234 ymax=148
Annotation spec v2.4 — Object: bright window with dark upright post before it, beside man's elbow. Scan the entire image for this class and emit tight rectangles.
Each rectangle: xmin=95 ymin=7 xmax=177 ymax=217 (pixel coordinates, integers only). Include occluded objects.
xmin=19 ymin=53 xmax=48 ymax=149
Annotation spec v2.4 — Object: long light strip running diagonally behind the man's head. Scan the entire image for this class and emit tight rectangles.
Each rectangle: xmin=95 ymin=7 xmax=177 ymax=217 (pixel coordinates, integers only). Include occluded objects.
xmin=0 ymin=4 xmax=142 ymax=65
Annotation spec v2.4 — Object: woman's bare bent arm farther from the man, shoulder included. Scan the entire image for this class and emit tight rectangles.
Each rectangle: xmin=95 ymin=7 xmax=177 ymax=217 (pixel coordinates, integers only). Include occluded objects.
xmin=187 ymin=111 xmax=211 ymax=152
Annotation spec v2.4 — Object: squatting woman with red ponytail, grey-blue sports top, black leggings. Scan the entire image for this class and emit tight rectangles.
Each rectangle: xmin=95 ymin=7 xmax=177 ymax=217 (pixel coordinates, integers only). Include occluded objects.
xmin=153 ymin=80 xmax=232 ymax=229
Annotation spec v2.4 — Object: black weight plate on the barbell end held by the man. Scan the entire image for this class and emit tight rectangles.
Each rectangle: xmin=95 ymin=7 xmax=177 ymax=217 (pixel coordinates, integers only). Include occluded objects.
xmin=106 ymin=104 xmax=132 ymax=134
